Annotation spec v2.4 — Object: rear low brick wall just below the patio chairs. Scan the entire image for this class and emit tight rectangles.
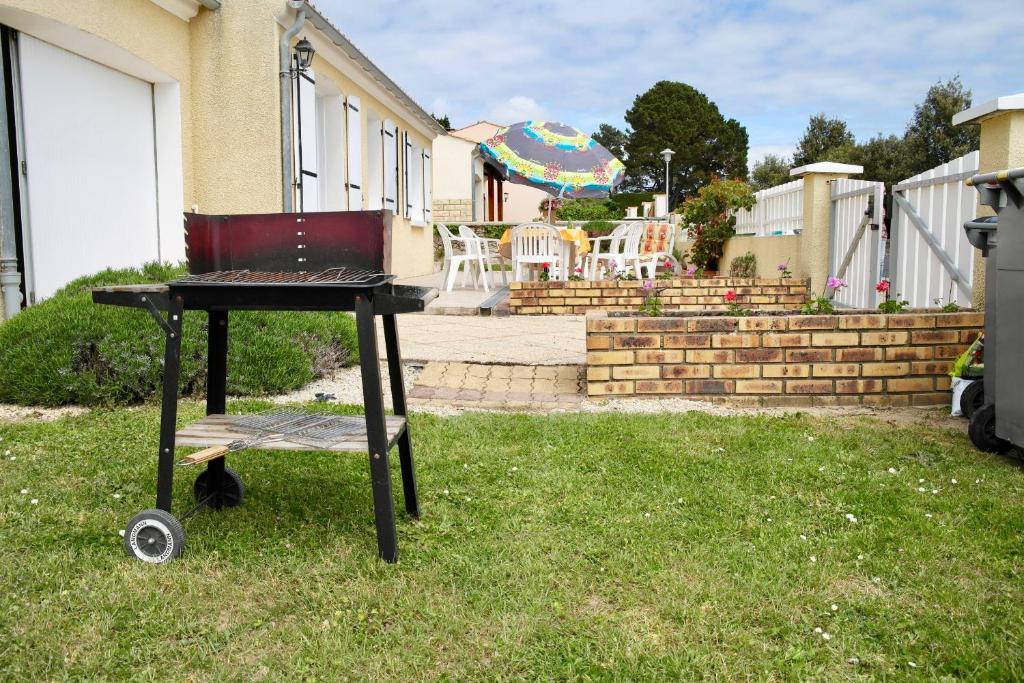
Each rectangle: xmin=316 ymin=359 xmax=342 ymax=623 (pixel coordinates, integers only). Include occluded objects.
xmin=509 ymin=278 xmax=809 ymax=315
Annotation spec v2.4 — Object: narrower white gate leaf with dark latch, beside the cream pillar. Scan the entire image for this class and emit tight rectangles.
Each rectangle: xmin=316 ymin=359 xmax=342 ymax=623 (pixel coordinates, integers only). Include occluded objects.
xmin=828 ymin=178 xmax=885 ymax=308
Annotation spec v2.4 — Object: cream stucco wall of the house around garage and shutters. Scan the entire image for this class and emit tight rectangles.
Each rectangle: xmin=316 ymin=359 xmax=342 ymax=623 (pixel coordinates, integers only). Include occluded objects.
xmin=0 ymin=0 xmax=444 ymax=276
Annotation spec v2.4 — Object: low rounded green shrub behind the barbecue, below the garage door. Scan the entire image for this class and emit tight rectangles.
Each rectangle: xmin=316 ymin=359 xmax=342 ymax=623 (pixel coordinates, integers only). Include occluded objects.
xmin=0 ymin=264 xmax=358 ymax=405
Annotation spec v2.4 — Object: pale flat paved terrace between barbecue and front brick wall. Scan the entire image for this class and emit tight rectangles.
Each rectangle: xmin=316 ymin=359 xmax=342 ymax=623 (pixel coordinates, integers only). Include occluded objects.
xmin=378 ymin=313 xmax=587 ymax=366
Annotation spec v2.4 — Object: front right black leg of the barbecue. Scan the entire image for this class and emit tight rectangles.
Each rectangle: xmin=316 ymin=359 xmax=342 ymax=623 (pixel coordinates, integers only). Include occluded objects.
xmin=355 ymin=295 xmax=398 ymax=562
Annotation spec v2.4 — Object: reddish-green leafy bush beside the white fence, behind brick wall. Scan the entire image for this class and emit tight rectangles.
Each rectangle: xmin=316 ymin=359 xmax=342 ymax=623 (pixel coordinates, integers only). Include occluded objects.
xmin=679 ymin=180 xmax=755 ymax=270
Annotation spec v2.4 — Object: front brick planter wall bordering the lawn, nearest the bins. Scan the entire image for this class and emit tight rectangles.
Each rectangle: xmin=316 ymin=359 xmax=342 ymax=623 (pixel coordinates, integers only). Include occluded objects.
xmin=587 ymin=311 xmax=984 ymax=407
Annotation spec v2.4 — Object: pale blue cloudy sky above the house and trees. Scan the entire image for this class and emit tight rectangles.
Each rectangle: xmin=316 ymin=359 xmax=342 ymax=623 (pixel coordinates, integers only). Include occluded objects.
xmin=316 ymin=0 xmax=1024 ymax=167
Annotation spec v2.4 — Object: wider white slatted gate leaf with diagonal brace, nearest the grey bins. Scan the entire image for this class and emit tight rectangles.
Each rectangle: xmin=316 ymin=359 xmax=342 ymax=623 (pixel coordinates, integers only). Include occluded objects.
xmin=889 ymin=152 xmax=979 ymax=307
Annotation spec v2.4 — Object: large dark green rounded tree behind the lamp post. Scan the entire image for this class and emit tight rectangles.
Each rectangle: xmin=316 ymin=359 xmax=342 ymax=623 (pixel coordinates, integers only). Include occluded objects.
xmin=625 ymin=81 xmax=748 ymax=205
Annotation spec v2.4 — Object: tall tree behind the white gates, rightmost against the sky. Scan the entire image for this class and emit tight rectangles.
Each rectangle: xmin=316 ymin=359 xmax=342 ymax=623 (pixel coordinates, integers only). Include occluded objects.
xmin=904 ymin=76 xmax=980 ymax=172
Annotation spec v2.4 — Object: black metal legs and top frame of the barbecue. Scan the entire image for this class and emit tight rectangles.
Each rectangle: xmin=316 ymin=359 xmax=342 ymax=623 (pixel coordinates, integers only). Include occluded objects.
xmin=92 ymin=278 xmax=437 ymax=562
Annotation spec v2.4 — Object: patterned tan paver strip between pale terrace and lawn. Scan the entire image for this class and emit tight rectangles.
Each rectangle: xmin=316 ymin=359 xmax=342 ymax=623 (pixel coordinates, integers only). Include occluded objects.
xmin=408 ymin=361 xmax=586 ymax=411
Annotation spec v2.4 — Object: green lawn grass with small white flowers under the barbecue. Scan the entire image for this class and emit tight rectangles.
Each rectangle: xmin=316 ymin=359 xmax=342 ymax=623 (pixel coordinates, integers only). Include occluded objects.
xmin=0 ymin=402 xmax=1024 ymax=681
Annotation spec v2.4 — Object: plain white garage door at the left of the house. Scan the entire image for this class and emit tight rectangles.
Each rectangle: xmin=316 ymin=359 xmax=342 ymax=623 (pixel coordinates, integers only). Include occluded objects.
xmin=18 ymin=34 xmax=160 ymax=301
